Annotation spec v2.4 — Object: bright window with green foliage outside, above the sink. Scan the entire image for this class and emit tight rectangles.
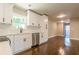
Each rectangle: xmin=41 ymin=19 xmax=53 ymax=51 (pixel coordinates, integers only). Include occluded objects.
xmin=12 ymin=13 xmax=26 ymax=29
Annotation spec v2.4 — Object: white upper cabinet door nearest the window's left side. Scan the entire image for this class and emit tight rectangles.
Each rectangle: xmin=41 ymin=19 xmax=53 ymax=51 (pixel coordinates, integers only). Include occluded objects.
xmin=4 ymin=3 xmax=13 ymax=24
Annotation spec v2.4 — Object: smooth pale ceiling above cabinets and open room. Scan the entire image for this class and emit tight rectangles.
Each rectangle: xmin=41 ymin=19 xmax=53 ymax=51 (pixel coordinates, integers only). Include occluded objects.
xmin=16 ymin=3 xmax=79 ymax=18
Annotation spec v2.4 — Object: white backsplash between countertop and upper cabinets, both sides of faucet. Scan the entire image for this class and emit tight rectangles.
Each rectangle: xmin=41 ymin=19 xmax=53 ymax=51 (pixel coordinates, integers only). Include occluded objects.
xmin=0 ymin=25 xmax=40 ymax=36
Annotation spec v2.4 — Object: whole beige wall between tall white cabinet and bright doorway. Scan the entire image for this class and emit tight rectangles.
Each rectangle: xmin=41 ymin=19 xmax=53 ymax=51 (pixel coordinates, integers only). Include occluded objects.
xmin=48 ymin=17 xmax=64 ymax=38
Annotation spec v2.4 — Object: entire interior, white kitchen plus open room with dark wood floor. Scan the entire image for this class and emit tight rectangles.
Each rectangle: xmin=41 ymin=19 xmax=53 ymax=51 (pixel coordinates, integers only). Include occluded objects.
xmin=0 ymin=3 xmax=79 ymax=55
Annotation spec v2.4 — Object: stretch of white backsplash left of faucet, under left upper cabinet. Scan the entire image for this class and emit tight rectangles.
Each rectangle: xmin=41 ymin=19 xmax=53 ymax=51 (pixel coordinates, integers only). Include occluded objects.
xmin=0 ymin=25 xmax=19 ymax=36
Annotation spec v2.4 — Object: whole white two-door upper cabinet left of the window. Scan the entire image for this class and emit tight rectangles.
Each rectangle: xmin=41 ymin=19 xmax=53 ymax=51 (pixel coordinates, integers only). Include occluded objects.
xmin=0 ymin=3 xmax=13 ymax=24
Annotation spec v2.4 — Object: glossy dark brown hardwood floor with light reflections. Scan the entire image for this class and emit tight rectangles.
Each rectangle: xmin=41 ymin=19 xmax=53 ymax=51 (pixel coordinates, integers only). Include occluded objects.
xmin=17 ymin=37 xmax=79 ymax=55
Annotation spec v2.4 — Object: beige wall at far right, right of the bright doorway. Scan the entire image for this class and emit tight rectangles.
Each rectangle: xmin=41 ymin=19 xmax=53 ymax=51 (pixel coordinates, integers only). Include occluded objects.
xmin=70 ymin=19 xmax=79 ymax=39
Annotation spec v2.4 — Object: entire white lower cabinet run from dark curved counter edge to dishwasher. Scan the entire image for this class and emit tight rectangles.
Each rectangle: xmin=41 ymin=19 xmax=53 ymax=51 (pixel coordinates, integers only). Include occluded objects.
xmin=7 ymin=33 xmax=32 ymax=54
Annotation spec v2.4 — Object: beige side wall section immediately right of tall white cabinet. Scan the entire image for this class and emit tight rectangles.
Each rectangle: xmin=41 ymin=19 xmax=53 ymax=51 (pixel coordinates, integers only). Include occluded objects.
xmin=48 ymin=18 xmax=57 ymax=38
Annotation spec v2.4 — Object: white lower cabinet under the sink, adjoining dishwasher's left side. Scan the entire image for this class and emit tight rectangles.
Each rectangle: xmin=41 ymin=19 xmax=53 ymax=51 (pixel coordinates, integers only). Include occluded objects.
xmin=14 ymin=34 xmax=32 ymax=53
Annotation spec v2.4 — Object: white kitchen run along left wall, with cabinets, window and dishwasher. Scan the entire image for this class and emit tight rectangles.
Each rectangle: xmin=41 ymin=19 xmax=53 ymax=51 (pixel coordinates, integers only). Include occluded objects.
xmin=0 ymin=3 xmax=48 ymax=55
